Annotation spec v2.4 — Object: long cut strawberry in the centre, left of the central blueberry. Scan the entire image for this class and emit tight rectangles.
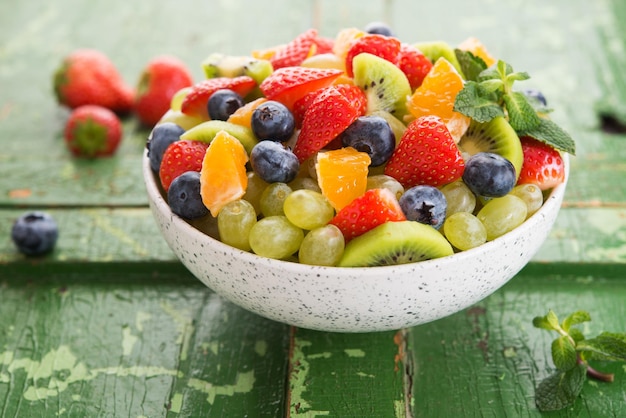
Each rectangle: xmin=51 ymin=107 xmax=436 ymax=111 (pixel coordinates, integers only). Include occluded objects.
xmin=293 ymin=85 xmax=365 ymax=163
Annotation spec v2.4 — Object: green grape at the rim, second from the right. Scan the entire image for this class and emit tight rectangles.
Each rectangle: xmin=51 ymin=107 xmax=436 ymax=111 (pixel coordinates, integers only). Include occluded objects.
xmin=476 ymin=194 xmax=528 ymax=241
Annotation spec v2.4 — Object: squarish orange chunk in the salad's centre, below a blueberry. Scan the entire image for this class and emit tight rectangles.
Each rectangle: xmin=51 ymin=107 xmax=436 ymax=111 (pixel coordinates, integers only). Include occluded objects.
xmin=315 ymin=147 xmax=371 ymax=211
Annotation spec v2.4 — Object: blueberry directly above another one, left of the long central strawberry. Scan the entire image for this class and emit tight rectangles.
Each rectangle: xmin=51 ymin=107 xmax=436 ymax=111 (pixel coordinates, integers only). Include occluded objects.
xmin=251 ymin=100 xmax=296 ymax=142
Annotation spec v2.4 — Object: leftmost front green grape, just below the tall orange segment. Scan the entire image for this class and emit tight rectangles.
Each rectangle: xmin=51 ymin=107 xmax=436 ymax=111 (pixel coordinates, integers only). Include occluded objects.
xmin=217 ymin=199 xmax=256 ymax=251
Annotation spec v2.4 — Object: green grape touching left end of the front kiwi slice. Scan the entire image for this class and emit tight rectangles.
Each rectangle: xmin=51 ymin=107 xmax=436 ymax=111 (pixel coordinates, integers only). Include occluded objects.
xmin=298 ymin=224 xmax=345 ymax=266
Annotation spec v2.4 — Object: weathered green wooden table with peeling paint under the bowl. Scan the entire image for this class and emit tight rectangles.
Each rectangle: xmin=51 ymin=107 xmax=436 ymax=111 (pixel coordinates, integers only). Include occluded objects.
xmin=0 ymin=0 xmax=626 ymax=417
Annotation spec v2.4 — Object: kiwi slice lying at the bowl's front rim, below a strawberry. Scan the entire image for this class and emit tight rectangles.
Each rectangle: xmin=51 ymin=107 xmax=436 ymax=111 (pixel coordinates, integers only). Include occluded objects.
xmin=338 ymin=221 xmax=454 ymax=267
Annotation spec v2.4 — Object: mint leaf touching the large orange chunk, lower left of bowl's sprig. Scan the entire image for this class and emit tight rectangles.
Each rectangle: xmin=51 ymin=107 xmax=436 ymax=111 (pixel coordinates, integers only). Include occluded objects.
xmin=454 ymin=81 xmax=504 ymax=123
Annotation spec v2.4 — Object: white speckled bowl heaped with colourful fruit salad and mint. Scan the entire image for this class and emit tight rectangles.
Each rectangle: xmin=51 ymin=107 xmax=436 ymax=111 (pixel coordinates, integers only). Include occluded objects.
xmin=143 ymin=29 xmax=574 ymax=332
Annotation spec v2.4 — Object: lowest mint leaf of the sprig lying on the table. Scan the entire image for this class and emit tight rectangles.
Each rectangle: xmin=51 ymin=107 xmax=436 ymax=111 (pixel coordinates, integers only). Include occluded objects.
xmin=535 ymin=364 xmax=587 ymax=411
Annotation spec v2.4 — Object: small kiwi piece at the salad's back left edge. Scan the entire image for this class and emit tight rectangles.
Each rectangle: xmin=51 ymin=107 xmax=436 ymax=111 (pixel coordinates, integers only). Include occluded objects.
xmin=202 ymin=53 xmax=274 ymax=84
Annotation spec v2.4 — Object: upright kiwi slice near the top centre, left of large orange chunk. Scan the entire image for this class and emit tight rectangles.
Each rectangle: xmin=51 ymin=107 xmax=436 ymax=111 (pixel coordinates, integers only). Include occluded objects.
xmin=352 ymin=52 xmax=411 ymax=120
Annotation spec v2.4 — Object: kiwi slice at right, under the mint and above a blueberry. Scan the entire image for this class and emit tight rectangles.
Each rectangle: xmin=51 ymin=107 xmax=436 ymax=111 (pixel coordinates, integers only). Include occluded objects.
xmin=458 ymin=116 xmax=524 ymax=177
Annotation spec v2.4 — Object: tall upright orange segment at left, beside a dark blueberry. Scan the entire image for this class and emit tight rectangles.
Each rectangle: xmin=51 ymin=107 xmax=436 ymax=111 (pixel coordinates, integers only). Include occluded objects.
xmin=200 ymin=131 xmax=248 ymax=216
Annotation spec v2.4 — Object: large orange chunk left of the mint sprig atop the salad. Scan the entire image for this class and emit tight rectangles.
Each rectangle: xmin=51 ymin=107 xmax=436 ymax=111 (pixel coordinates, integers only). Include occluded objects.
xmin=407 ymin=58 xmax=470 ymax=142
